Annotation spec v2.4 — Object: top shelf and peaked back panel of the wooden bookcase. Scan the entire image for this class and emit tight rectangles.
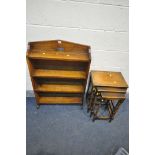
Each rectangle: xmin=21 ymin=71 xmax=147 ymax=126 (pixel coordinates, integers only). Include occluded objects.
xmin=27 ymin=40 xmax=91 ymax=62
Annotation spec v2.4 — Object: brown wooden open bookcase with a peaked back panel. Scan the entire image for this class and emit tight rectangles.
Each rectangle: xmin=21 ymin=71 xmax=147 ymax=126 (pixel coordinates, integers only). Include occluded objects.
xmin=27 ymin=40 xmax=91 ymax=108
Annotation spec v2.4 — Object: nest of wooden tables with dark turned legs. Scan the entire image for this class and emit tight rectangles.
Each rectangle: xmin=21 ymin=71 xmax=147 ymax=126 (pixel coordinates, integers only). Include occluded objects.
xmin=87 ymin=71 xmax=128 ymax=121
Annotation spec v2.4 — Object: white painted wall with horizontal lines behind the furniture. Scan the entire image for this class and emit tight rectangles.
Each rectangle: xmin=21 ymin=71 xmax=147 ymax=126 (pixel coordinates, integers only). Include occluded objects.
xmin=27 ymin=0 xmax=129 ymax=90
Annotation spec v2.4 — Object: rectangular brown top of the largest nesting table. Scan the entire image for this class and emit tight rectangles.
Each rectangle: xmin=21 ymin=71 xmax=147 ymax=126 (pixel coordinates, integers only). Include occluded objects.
xmin=91 ymin=71 xmax=128 ymax=88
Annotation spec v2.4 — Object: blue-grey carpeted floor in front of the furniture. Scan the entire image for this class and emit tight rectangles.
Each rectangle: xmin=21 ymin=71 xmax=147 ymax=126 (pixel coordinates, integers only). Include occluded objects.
xmin=26 ymin=97 xmax=129 ymax=155
